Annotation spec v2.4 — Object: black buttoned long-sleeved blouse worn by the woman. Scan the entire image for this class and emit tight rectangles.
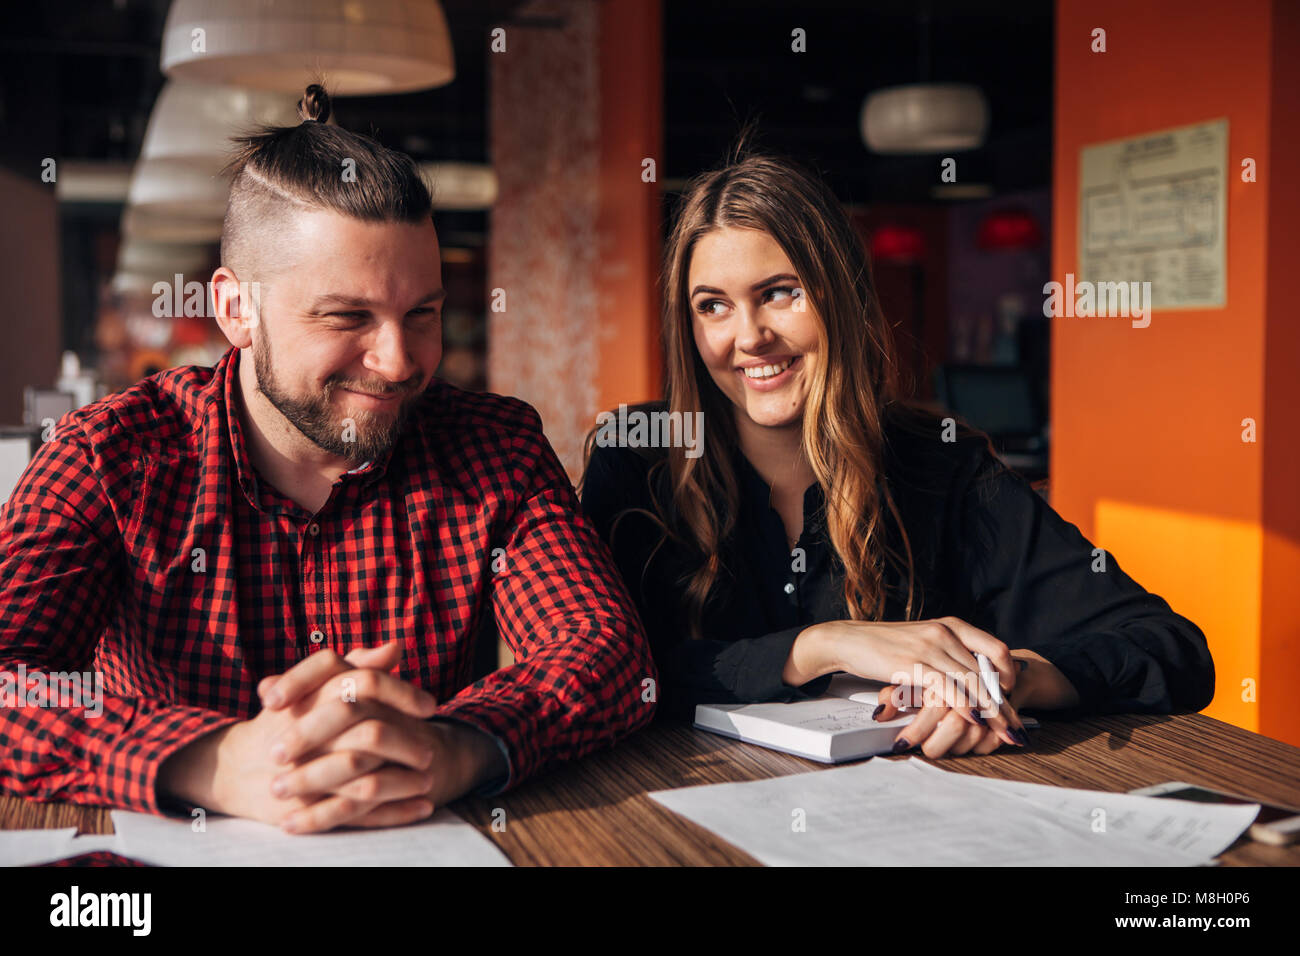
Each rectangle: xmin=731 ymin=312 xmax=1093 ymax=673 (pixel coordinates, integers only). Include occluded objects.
xmin=582 ymin=406 xmax=1214 ymax=718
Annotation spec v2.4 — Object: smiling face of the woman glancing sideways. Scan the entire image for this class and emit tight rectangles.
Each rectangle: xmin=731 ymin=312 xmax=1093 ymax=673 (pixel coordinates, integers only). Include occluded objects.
xmin=686 ymin=226 xmax=819 ymax=428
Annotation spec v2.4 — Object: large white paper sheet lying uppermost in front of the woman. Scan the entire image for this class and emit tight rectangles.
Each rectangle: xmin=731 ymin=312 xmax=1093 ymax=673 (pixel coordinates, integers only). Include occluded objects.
xmin=650 ymin=760 xmax=1227 ymax=866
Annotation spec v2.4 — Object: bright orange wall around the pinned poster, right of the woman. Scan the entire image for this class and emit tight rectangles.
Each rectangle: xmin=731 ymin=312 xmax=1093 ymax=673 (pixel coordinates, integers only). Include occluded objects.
xmin=1052 ymin=0 xmax=1300 ymax=744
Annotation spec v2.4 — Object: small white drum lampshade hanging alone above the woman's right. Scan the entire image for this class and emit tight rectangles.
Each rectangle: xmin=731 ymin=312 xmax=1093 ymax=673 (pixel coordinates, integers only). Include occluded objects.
xmin=861 ymin=83 xmax=988 ymax=153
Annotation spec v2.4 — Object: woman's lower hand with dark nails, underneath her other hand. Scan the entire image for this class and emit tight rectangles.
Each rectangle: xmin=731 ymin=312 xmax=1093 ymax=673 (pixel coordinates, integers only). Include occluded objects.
xmin=872 ymin=658 xmax=1034 ymax=760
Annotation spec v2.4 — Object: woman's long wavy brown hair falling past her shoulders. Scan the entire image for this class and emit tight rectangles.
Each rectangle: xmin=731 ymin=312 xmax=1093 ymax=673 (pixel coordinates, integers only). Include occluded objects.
xmin=657 ymin=155 xmax=915 ymax=637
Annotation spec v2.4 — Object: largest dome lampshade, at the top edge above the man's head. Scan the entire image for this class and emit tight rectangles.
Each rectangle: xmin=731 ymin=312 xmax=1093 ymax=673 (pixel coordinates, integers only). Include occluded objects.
xmin=161 ymin=0 xmax=456 ymax=96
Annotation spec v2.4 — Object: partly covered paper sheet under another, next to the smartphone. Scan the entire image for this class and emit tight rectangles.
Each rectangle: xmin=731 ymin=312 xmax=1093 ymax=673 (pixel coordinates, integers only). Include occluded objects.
xmin=900 ymin=757 xmax=1260 ymax=862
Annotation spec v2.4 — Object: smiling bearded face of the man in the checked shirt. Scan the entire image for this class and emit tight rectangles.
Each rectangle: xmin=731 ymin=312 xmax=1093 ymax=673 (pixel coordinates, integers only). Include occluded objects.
xmin=245 ymin=212 xmax=443 ymax=466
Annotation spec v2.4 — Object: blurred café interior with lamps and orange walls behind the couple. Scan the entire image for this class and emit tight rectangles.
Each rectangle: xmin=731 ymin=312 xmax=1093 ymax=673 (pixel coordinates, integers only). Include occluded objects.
xmin=0 ymin=0 xmax=1300 ymax=744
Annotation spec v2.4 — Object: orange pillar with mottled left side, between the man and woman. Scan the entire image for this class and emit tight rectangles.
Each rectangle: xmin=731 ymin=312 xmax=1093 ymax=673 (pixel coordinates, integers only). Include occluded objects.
xmin=488 ymin=0 xmax=663 ymax=479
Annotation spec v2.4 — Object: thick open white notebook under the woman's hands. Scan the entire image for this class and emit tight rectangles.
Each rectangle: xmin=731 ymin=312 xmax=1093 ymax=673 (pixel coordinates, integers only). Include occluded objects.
xmin=696 ymin=674 xmax=1037 ymax=763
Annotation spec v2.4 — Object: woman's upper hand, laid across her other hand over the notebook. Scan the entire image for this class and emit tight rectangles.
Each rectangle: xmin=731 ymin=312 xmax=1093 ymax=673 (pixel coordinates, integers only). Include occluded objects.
xmin=784 ymin=618 xmax=1019 ymax=744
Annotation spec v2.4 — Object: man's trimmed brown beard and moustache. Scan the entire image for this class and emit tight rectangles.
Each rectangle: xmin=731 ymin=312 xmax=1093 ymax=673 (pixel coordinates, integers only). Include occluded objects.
xmin=252 ymin=329 xmax=415 ymax=466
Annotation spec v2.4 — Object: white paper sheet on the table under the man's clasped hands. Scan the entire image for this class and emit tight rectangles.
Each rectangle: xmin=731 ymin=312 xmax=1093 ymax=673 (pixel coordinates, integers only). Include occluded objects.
xmin=112 ymin=808 xmax=511 ymax=866
